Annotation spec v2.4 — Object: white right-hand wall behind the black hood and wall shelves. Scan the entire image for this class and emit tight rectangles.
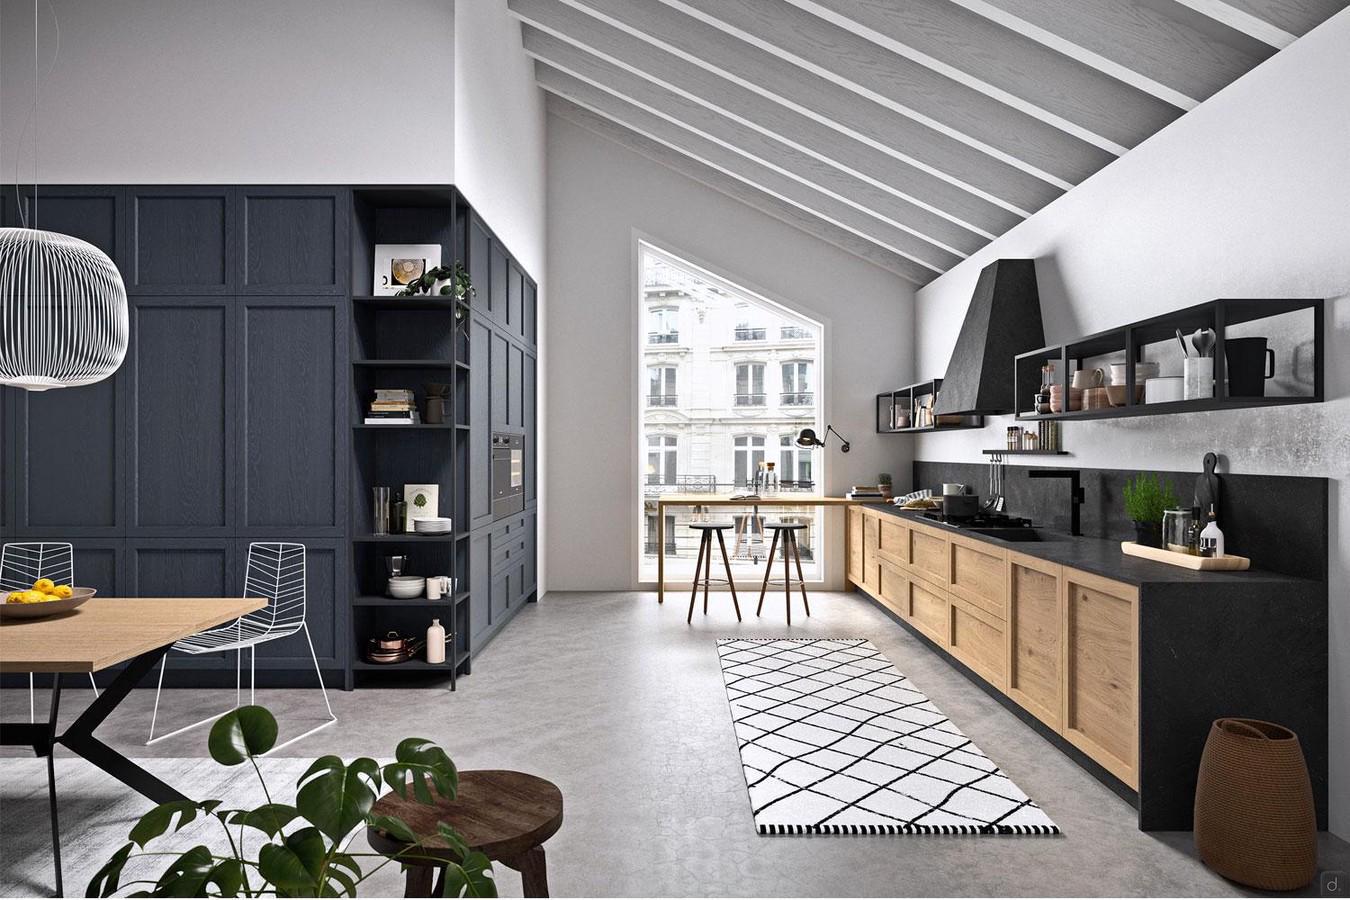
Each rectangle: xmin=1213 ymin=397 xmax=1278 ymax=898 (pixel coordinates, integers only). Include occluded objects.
xmin=917 ymin=11 xmax=1350 ymax=837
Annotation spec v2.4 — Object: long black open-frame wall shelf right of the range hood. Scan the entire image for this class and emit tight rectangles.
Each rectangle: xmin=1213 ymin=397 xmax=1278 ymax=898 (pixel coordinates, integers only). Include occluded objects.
xmin=1014 ymin=300 xmax=1326 ymax=421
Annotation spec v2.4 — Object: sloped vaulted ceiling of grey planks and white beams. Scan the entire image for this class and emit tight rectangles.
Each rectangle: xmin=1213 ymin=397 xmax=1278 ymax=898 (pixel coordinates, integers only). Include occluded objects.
xmin=508 ymin=0 xmax=1347 ymax=285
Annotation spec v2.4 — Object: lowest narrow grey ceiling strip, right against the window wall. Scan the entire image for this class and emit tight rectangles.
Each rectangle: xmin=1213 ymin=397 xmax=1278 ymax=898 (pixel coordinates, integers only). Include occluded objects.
xmin=547 ymin=93 xmax=937 ymax=286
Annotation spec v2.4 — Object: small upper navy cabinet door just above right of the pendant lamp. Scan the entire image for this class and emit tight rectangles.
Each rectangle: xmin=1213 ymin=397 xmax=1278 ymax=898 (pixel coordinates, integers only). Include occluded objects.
xmin=122 ymin=186 xmax=238 ymax=297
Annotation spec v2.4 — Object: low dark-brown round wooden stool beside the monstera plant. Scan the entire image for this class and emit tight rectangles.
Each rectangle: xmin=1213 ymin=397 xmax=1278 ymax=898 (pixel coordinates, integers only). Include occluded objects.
xmin=366 ymin=769 xmax=563 ymax=897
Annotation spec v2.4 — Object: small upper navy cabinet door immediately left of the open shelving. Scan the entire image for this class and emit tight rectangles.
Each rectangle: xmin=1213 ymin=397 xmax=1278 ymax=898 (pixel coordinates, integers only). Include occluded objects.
xmin=236 ymin=186 xmax=350 ymax=296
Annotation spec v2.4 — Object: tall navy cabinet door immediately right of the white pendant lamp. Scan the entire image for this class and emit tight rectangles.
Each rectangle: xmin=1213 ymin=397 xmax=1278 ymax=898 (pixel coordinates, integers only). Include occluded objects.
xmin=127 ymin=297 xmax=238 ymax=536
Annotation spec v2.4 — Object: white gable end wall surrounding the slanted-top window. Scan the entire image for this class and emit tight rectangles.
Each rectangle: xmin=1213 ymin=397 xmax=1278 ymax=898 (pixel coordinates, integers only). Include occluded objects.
xmin=544 ymin=116 xmax=913 ymax=590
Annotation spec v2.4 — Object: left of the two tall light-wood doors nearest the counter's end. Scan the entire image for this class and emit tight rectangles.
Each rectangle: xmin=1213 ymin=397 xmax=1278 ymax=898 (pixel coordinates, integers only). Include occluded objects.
xmin=1006 ymin=553 xmax=1064 ymax=731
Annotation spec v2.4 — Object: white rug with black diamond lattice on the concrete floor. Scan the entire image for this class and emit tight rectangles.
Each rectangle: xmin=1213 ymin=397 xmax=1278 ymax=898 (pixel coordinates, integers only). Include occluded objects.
xmin=717 ymin=638 xmax=1060 ymax=834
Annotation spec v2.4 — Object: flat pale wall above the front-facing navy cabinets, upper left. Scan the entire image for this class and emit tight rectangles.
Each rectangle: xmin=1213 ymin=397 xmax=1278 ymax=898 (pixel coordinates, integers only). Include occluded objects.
xmin=0 ymin=0 xmax=456 ymax=184
